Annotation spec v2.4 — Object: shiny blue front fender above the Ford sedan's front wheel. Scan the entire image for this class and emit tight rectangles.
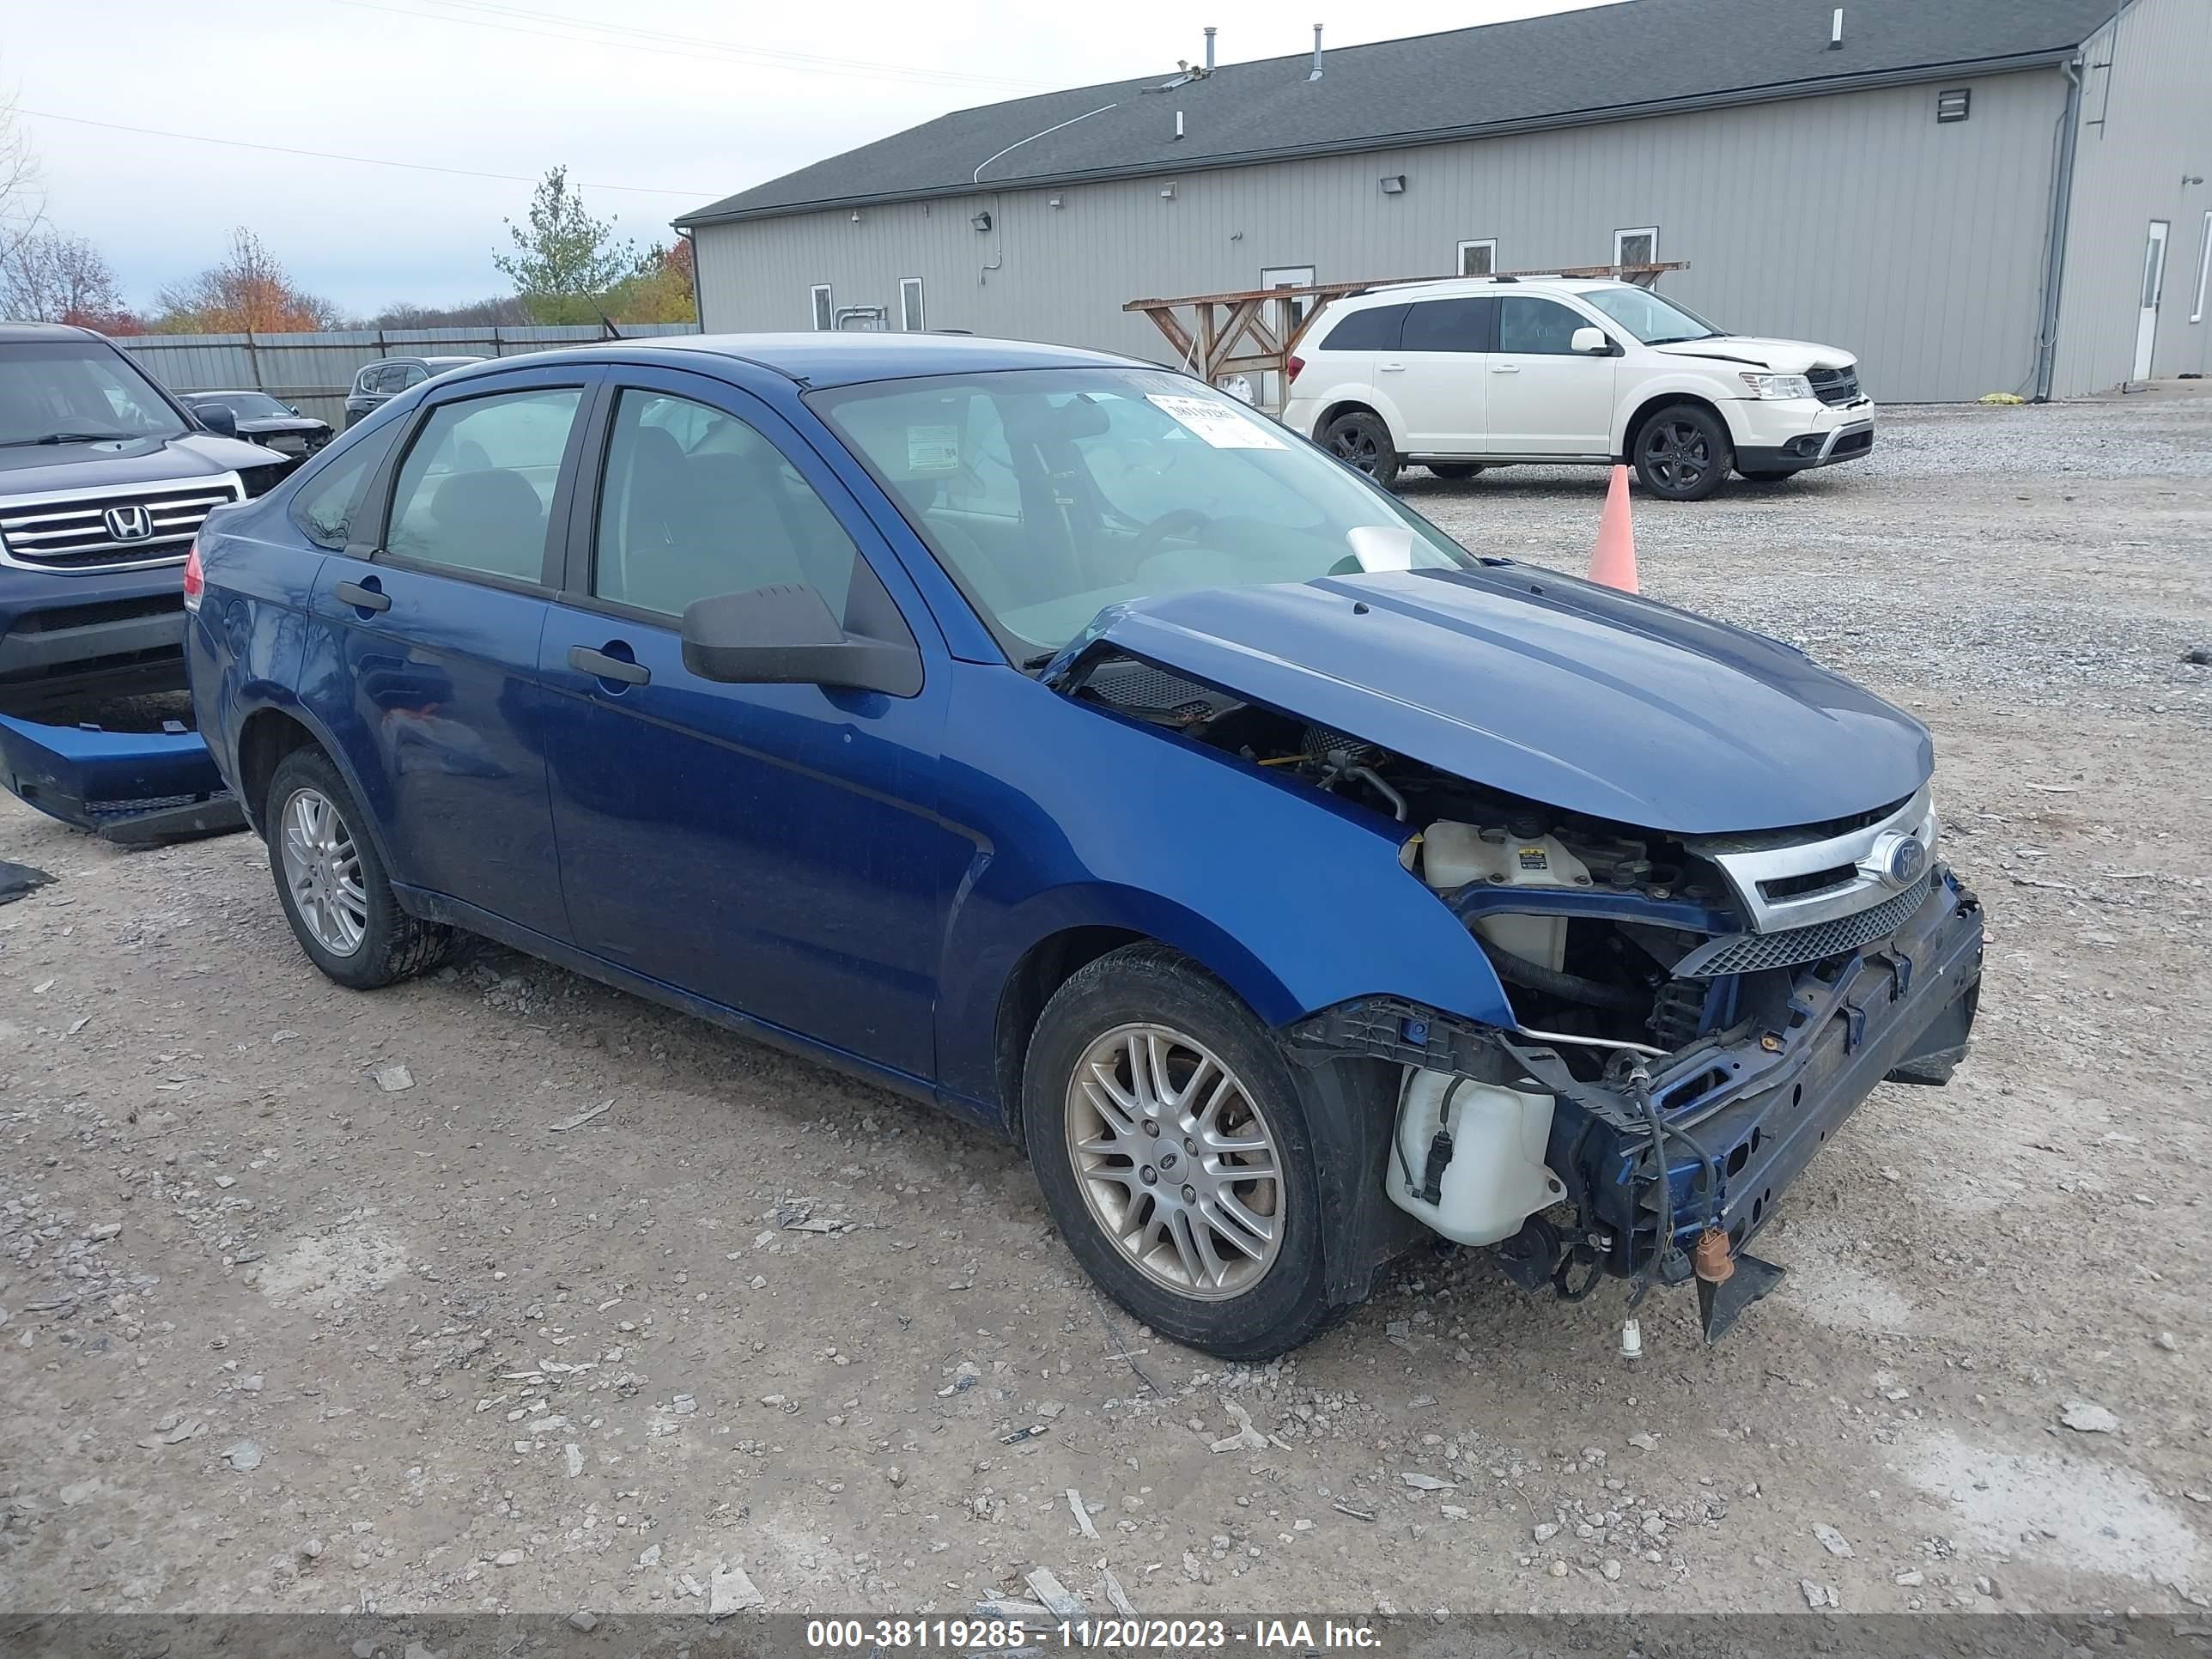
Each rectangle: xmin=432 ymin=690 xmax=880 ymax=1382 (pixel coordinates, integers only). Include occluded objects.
xmin=938 ymin=668 xmax=1510 ymax=1099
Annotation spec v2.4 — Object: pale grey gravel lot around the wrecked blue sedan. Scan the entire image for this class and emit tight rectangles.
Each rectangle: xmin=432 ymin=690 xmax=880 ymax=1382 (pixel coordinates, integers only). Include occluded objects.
xmin=0 ymin=396 xmax=2212 ymax=1613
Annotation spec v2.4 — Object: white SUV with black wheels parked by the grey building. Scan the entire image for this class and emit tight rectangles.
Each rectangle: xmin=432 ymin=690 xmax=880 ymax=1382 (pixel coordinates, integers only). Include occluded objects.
xmin=1283 ymin=276 xmax=1874 ymax=502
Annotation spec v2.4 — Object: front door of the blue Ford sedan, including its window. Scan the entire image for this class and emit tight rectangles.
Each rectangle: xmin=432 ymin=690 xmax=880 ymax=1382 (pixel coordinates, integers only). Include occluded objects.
xmin=540 ymin=369 xmax=975 ymax=1078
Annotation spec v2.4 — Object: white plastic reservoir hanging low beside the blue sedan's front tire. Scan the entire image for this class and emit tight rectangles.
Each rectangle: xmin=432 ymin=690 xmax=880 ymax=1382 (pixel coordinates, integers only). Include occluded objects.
xmin=1385 ymin=1071 xmax=1566 ymax=1245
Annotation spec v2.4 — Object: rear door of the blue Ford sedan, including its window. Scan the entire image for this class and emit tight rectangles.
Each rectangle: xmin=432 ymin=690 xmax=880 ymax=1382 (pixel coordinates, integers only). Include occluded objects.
xmin=301 ymin=365 xmax=599 ymax=940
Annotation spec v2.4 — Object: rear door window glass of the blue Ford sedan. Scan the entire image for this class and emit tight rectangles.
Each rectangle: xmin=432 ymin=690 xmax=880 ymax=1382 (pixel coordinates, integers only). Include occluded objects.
xmin=385 ymin=387 xmax=584 ymax=581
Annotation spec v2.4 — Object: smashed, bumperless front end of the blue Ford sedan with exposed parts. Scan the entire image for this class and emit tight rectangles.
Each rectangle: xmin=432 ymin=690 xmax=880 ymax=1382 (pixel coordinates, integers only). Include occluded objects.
xmin=1055 ymin=615 xmax=1982 ymax=1340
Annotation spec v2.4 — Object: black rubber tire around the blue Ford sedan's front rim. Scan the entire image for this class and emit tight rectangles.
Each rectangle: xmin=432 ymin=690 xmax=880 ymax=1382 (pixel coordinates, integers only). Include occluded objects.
xmin=1022 ymin=945 xmax=1338 ymax=1360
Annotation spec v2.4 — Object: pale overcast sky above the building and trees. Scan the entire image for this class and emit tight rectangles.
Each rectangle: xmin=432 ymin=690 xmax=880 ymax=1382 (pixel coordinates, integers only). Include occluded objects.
xmin=0 ymin=0 xmax=1619 ymax=314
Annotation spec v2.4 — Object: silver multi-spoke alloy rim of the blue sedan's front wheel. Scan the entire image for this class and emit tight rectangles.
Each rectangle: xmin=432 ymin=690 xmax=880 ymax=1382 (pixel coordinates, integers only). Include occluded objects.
xmin=1064 ymin=1024 xmax=1285 ymax=1301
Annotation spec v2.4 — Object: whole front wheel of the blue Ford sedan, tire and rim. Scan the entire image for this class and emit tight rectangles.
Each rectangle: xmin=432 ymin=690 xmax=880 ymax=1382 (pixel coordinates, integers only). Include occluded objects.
xmin=1022 ymin=945 xmax=1332 ymax=1360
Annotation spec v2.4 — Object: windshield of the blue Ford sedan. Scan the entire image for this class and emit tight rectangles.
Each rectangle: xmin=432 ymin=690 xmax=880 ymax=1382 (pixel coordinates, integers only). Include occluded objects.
xmin=807 ymin=368 xmax=1471 ymax=664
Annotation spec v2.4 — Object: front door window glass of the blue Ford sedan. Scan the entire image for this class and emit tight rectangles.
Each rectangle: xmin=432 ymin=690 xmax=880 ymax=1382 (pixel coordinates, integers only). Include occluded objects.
xmin=591 ymin=387 xmax=860 ymax=617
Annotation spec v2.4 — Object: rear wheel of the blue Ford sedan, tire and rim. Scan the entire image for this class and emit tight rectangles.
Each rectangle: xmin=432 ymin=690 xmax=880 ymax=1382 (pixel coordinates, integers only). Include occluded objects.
xmin=261 ymin=748 xmax=453 ymax=991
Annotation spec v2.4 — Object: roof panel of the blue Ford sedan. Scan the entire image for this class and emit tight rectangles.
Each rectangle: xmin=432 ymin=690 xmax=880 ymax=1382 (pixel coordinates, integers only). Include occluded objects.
xmin=440 ymin=330 xmax=1159 ymax=387
